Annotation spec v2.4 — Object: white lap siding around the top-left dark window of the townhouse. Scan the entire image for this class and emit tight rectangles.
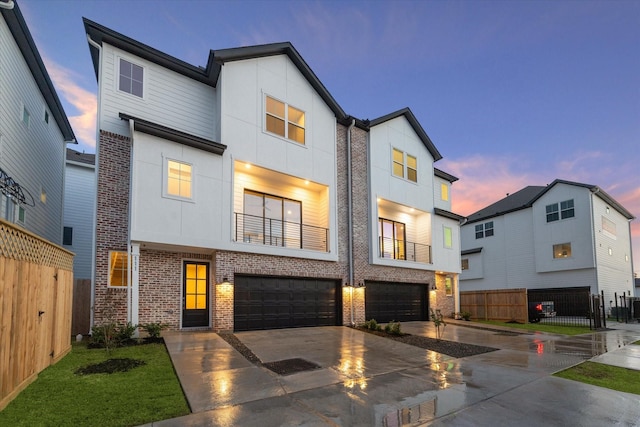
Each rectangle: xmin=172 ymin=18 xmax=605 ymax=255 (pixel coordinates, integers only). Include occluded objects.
xmin=98 ymin=43 xmax=220 ymax=140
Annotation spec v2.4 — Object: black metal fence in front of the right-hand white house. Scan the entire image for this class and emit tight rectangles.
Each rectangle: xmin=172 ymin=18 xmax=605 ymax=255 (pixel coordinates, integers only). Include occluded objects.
xmin=527 ymin=287 xmax=606 ymax=329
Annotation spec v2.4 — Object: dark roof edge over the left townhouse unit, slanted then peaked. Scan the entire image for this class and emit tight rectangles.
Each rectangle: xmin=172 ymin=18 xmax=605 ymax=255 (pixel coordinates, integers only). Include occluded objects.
xmin=82 ymin=18 xmax=347 ymax=121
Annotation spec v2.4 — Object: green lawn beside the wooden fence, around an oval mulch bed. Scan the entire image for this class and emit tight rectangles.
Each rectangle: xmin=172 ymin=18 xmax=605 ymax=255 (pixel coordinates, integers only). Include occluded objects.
xmin=0 ymin=343 xmax=189 ymax=426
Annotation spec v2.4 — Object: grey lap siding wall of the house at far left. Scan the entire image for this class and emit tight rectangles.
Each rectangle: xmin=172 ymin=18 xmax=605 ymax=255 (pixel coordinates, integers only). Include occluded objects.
xmin=0 ymin=16 xmax=65 ymax=245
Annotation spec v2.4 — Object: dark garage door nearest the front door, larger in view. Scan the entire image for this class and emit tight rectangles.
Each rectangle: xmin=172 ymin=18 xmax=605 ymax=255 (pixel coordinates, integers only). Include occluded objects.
xmin=233 ymin=275 xmax=342 ymax=331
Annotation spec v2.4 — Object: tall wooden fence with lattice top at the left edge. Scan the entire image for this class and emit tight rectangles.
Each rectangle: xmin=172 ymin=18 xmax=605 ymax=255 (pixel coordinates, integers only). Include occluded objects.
xmin=0 ymin=220 xmax=73 ymax=410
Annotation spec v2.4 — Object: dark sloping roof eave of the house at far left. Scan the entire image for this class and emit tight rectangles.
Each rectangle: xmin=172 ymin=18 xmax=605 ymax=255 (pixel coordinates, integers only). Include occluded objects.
xmin=0 ymin=2 xmax=77 ymax=140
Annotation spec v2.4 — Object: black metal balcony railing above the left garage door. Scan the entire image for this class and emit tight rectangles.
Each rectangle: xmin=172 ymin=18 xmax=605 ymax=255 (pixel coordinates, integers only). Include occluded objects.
xmin=235 ymin=212 xmax=329 ymax=252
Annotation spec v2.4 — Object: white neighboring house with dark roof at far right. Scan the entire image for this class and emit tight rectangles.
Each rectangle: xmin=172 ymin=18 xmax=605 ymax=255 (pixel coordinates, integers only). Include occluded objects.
xmin=460 ymin=180 xmax=634 ymax=308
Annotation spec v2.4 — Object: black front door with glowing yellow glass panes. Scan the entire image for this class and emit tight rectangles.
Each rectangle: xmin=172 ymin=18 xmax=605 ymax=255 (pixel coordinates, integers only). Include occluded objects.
xmin=182 ymin=261 xmax=209 ymax=328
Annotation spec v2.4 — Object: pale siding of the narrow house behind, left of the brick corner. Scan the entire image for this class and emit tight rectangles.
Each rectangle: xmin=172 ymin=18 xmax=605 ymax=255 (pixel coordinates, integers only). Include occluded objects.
xmin=64 ymin=162 xmax=96 ymax=279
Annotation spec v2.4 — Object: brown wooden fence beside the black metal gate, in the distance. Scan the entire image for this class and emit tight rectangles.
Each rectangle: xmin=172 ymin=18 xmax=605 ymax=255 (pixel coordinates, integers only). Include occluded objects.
xmin=460 ymin=288 xmax=529 ymax=323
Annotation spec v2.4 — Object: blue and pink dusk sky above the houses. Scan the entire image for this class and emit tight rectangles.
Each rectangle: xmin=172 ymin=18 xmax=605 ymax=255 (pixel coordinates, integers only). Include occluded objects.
xmin=18 ymin=0 xmax=640 ymax=271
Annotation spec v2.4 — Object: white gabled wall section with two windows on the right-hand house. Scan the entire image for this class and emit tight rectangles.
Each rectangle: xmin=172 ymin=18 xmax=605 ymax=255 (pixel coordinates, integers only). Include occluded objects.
xmin=532 ymin=184 xmax=595 ymax=273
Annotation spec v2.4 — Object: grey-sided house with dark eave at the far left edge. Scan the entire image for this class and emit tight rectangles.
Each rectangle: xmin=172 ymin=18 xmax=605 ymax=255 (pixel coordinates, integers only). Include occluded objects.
xmin=0 ymin=1 xmax=75 ymax=245
